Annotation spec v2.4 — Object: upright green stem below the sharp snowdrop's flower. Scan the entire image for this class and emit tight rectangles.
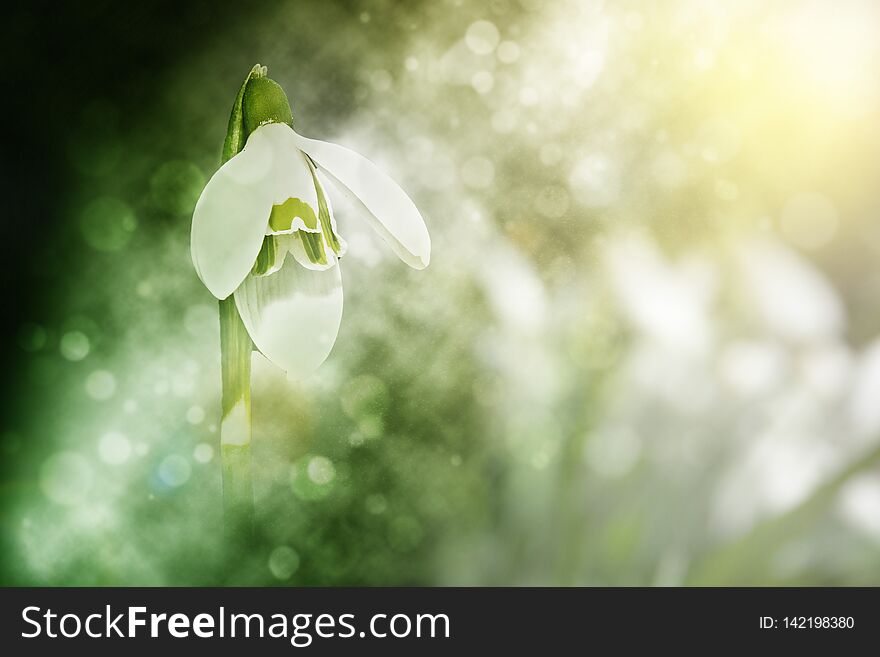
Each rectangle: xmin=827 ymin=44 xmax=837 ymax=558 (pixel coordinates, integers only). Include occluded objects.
xmin=220 ymin=296 xmax=254 ymax=542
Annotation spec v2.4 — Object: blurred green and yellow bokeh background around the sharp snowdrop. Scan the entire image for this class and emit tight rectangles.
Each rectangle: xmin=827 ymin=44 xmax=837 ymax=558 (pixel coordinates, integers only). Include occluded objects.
xmin=0 ymin=0 xmax=880 ymax=585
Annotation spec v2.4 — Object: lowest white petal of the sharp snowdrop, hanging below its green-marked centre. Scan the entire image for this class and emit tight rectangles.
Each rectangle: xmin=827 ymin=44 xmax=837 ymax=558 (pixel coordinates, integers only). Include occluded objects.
xmin=235 ymin=251 xmax=342 ymax=379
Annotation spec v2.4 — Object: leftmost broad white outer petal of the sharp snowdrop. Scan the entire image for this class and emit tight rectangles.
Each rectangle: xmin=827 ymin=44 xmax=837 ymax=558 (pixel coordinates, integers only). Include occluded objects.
xmin=191 ymin=124 xmax=318 ymax=299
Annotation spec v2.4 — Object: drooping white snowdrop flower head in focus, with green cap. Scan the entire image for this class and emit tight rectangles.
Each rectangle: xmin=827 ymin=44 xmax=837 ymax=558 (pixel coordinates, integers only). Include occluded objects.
xmin=191 ymin=67 xmax=431 ymax=378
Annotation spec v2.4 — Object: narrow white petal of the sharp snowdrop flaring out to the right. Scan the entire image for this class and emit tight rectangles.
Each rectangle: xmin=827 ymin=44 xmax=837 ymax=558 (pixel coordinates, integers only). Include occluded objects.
xmin=293 ymin=132 xmax=431 ymax=269
